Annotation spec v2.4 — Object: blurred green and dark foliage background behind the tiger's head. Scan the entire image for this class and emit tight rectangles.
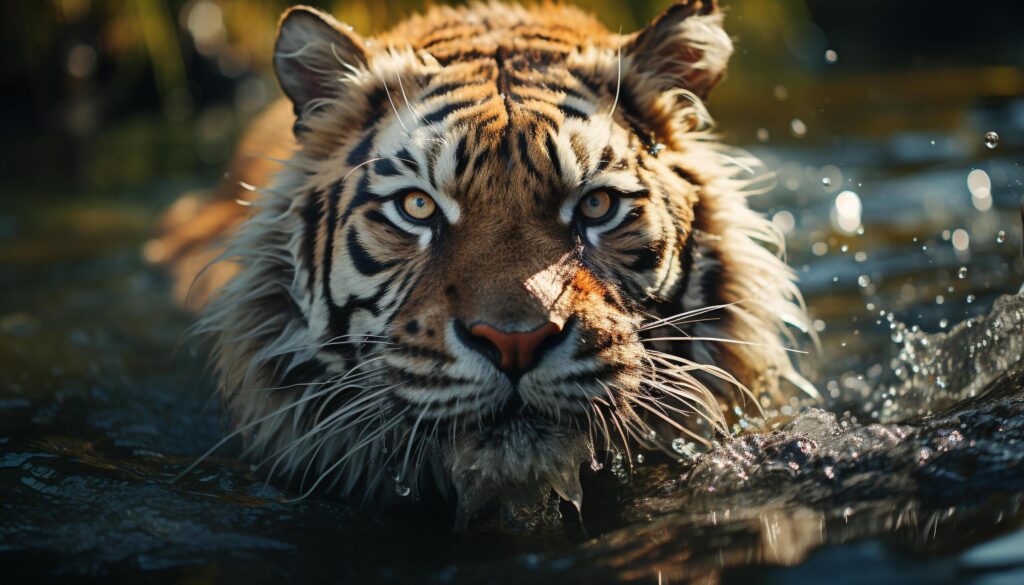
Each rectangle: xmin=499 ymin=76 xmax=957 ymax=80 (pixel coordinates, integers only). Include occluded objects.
xmin=0 ymin=0 xmax=1024 ymax=193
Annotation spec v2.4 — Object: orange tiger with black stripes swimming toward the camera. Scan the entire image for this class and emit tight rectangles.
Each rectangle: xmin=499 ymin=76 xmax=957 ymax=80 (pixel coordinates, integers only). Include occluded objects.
xmin=160 ymin=1 xmax=813 ymax=523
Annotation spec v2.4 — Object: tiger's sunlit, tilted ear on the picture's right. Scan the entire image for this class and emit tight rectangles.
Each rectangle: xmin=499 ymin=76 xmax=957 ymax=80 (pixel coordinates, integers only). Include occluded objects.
xmin=623 ymin=0 xmax=732 ymax=99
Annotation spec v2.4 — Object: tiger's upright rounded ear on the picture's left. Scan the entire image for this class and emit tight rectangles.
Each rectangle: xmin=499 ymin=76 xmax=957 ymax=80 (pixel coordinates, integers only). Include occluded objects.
xmin=273 ymin=6 xmax=368 ymax=117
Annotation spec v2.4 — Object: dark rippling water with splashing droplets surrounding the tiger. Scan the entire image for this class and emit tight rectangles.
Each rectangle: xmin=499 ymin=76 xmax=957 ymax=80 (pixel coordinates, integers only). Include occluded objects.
xmin=0 ymin=100 xmax=1024 ymax=584
